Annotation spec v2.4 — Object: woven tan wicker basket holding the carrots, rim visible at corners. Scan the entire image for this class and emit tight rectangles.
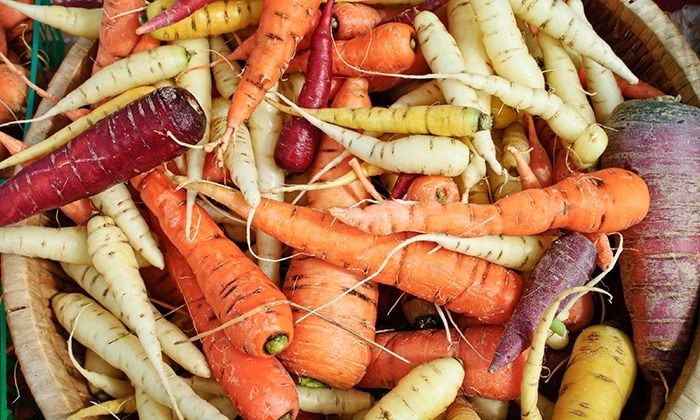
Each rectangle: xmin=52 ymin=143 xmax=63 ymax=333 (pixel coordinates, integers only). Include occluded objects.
xmin=2 ymin=0 xmax=700 ymax=419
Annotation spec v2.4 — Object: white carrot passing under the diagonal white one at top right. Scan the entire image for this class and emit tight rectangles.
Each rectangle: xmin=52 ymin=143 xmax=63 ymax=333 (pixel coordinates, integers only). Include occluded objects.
xmin=569 ymin=0 xmax=625 ymax=123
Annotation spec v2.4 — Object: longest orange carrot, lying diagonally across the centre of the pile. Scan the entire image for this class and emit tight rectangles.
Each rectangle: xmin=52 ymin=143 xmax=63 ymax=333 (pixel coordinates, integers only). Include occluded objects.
xmin=178 ymin=181 xmax=522 ymax=324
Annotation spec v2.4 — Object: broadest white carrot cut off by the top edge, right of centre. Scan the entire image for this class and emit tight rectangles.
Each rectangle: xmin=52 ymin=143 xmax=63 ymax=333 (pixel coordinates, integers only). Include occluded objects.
xmin=471 ymin=0 xmax=544 ymax=89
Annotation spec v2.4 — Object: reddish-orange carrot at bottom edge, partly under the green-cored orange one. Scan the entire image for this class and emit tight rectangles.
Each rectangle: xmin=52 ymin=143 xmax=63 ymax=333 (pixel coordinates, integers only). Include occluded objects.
xmin=161 ymin=230 xmax=299 ymax=420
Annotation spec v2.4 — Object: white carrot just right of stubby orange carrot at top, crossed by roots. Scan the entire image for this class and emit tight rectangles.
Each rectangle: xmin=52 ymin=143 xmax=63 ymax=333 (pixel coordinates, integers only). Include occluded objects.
xmin=414 ymin=11 xmax=503 ymax=176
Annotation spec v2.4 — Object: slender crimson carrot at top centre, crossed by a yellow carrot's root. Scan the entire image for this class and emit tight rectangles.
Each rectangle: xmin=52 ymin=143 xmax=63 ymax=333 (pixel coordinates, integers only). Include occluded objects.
xmin=275 ymin=0 xmax=333 ymax=172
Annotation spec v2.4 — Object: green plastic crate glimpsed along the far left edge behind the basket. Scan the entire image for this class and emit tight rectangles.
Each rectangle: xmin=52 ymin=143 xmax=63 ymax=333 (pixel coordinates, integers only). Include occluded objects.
xmin=0 ymin=0 xmax=66 ymax=420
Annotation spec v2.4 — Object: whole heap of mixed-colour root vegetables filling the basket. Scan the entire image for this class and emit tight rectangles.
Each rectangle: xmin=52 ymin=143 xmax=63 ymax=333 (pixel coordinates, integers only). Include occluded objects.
xmin=0 ymin=0 xmax=700 ymax=420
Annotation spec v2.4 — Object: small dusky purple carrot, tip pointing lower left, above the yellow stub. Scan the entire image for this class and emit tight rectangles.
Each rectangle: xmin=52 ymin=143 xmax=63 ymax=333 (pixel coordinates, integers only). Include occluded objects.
xmin=489 ymin=232 xmax=597 ymax=373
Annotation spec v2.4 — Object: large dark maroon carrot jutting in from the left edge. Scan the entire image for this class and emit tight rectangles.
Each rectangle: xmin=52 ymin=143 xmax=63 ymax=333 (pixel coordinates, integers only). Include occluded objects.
xmin=0 ymin=87 xmax=206 ymax=226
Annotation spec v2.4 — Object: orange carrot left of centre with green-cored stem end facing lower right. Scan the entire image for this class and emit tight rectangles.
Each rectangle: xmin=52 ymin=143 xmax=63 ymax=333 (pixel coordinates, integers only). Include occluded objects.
xmin=132 ymin=170 xmax=293 ymax=357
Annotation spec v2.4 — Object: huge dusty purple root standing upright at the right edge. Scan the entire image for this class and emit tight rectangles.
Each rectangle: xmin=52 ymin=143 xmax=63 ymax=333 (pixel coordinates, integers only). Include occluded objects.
xmin=601 ymin=100 xmax=700 ymax=416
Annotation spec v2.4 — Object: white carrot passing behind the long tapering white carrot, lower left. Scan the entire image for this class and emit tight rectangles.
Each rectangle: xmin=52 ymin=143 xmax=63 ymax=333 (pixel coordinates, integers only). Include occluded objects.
xmin=61 ymin=264 xmax=211 ymax=377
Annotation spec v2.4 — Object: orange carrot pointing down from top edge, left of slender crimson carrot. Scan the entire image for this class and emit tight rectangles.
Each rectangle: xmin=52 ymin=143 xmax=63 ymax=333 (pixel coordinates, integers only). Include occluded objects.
xmin=220 ymin=0 xmax=321 ymax=155
